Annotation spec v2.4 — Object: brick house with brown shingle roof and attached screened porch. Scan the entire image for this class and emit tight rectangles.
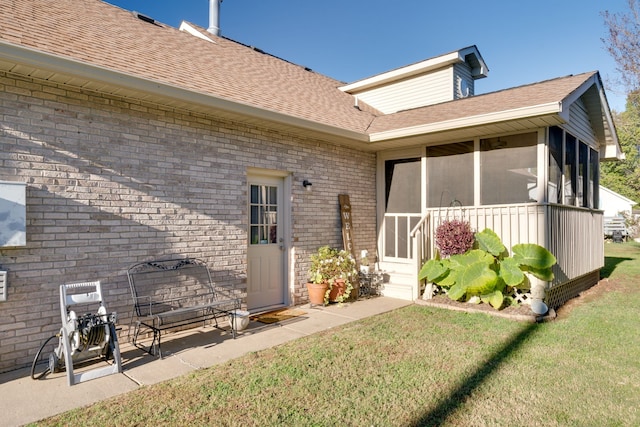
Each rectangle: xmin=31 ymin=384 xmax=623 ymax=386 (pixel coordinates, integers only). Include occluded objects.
xmin=0 ymin=0 xmax=621 ymax=371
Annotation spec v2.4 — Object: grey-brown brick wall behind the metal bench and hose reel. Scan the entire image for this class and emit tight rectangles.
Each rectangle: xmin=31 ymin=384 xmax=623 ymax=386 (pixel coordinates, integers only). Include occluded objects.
xmin=0 ymin=73 xmax=376 ymax=372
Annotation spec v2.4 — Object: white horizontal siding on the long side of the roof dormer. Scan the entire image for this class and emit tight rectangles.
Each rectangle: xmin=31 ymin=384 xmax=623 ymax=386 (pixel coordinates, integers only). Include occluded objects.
xmin=354 ymin=67 xmax=454 ymax=114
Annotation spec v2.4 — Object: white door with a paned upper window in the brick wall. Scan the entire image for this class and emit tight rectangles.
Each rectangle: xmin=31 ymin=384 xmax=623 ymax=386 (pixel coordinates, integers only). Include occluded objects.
xmin=247 ymin=176 xmax=286 ymax=311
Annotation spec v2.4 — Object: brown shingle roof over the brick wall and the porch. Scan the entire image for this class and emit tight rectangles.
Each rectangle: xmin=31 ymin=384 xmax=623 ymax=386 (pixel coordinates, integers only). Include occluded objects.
xmin=0 ymin=0 xmax=612 ymax=147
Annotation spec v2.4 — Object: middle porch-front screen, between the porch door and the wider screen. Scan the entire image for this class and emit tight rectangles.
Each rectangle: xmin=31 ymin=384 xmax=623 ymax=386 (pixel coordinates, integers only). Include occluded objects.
xmin=427 ymin=141 xmax=474 ymax=208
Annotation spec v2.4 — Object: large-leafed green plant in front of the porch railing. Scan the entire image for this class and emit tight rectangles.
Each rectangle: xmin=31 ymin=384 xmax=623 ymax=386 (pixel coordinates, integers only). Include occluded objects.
xmin=419 ymin=228 xmax=556 ymax=309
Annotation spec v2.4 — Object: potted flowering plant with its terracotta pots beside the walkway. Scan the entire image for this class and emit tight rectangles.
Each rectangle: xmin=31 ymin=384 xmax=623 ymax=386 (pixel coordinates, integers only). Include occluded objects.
xmin=307 ymin=246 xmax=358 ymax=304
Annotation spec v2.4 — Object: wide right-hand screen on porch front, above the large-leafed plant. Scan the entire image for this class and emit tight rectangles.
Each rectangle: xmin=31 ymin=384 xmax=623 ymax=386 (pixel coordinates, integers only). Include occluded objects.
xmin=480 ymin=132 xmax=538 ymax=205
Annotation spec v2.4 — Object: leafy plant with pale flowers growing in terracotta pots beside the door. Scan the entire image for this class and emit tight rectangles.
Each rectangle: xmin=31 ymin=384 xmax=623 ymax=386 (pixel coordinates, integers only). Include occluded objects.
xmin=309 ymin=246 xmax=358 ymax=302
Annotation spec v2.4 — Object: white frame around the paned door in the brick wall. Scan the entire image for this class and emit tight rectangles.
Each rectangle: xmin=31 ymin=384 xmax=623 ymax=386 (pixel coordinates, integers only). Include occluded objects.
xmin=245 ymin=167 xmax=295 ymax=311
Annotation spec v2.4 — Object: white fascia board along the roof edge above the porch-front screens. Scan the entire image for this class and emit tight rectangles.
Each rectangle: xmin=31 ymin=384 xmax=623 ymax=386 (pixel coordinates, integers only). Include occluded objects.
xmin=369 ymin=102 xmax=562 ymax=142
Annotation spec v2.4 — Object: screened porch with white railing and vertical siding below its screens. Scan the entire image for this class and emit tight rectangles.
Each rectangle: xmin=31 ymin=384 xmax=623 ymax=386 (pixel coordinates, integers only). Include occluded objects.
xmin=380 ymin=126 xmax=604 ymax=307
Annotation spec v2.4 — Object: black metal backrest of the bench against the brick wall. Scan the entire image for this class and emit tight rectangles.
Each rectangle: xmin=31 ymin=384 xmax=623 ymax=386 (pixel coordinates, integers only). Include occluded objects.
xmin=127 ymin=258 xmax=220 ymax=316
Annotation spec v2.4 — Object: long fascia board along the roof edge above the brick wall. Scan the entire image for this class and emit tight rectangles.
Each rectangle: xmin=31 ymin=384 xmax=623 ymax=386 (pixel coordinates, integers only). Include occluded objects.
xmin=0 ymin=41 xmax=368 ymax=142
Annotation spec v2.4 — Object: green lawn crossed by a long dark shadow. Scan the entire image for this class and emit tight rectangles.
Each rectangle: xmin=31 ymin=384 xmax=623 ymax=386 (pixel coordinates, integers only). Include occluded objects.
xmin=32 ymin=243 xmax=640 ymax=426
